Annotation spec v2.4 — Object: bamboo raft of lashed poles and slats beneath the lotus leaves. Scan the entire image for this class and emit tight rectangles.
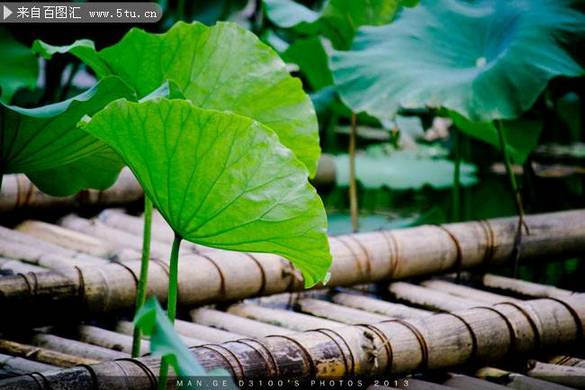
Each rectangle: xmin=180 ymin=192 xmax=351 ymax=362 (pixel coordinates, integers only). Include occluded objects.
xmin=0 ymin=209 xmax=585 ymax=389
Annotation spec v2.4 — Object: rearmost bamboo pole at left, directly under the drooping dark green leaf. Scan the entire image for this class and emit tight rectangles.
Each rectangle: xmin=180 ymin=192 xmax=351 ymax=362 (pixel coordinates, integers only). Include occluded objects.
xmin=0 ymin=169 xmax=144 ymax=212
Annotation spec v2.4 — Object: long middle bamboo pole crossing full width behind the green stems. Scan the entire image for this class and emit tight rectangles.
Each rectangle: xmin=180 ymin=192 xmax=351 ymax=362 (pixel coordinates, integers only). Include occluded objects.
xmin=0 ymin=210 xmax=585 ymax=321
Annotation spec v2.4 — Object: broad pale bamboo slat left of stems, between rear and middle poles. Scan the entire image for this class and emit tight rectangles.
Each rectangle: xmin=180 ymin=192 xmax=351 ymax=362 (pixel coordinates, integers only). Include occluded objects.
xmin=16 ymin=220 xmax=115 ymax=258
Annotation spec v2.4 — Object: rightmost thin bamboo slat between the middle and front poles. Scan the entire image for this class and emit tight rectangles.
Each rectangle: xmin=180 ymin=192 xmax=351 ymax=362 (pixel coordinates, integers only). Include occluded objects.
xmin=482 ymin=274 xmax=574 ymax=298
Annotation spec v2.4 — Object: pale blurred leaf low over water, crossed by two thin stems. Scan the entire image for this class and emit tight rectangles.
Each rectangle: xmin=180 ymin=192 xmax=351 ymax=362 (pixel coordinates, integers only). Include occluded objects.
xmin=334 ymin=150 xmax=477 ymax=190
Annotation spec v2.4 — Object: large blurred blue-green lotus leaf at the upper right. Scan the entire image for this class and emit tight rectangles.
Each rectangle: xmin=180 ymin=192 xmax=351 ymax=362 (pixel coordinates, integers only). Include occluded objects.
xmin=331 ymin=0 xmax=585 ymax=121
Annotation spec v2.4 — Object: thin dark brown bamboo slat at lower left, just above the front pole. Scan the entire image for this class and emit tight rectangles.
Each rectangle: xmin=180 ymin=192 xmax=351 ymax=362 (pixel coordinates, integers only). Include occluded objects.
xmin=0 ymin=339 xmax=99 ymax=367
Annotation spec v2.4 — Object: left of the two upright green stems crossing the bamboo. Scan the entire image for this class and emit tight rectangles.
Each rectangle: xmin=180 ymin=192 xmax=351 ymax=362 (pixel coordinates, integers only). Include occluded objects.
xmin=132 ymin=194 xmax=152 ymax=357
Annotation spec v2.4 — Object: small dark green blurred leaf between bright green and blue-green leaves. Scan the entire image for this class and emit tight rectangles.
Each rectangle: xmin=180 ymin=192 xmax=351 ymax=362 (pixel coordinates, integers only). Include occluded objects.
xmin=282 ymin=37 xmax=333 ymax=90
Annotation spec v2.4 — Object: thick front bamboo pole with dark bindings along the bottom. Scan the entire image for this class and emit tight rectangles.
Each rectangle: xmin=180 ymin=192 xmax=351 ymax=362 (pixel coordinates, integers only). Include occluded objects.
xmin=0 ymin=295 xmax=585 ymax=390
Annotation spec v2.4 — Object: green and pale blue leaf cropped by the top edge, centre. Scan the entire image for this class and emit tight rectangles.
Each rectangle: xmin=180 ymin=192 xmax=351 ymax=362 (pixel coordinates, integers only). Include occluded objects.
xmin=264 ymin=0 xmax=415 ymax=50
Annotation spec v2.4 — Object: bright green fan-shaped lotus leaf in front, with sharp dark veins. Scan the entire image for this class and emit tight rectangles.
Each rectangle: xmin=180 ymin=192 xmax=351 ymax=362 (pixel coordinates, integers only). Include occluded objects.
xmin=84 ymin=99 xmax=331 ymax=286
